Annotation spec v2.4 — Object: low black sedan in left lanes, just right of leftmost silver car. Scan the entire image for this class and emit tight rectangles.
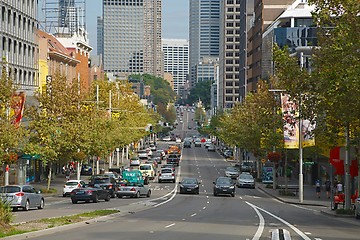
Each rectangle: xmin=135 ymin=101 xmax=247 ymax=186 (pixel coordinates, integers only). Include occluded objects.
xmin=70 ymin=187 xmax=110 ymax=204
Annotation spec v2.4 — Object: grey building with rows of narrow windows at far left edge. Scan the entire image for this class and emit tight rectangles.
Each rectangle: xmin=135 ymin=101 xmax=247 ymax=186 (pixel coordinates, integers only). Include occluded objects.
xmin=0 ymin=0 xmax=39 ymax=96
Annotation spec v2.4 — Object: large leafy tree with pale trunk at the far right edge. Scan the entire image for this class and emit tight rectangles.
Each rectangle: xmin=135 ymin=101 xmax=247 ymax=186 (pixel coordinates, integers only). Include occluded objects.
xmin=309 ymin=0 xmax=360 ymax=209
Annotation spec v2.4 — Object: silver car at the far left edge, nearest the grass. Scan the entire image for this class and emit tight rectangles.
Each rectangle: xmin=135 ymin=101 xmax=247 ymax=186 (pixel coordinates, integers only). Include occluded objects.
xmin=0 ymin=185 xmax=45 ymax=211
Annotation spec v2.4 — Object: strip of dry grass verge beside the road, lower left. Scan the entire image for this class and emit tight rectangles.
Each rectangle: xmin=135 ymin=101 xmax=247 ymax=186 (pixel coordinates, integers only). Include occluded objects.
xmin=0 ymin=210 xmax=119 ymax=238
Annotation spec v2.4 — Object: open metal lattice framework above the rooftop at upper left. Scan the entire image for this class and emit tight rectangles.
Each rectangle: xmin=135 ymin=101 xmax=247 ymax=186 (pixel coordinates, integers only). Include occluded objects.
xmin=40 ymin=0 xmax=86 ymax=36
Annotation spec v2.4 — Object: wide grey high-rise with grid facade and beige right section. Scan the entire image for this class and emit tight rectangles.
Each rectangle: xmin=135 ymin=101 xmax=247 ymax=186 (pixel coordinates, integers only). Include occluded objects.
xmin=103 ymin=0 xmax=163 ymax=76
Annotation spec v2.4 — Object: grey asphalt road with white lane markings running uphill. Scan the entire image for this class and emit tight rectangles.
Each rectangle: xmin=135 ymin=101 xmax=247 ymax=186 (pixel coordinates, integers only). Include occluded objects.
xmin=11 ymin=114 xmax=360 ymax=240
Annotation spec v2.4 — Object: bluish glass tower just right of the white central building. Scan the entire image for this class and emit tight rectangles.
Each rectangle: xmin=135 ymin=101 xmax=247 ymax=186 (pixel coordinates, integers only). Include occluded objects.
xmin=189 ymin=0 xmax=220 ymax=86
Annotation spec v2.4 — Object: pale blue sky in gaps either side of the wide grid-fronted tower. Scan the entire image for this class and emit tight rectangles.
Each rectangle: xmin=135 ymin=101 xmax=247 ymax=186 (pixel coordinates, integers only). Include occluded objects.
xmin=86 ymin=0 xmax=190 ymax=55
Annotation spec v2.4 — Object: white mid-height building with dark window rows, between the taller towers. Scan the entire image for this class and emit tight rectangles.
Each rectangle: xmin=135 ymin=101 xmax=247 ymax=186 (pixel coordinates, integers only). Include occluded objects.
xmin=162 ymin=39 xmax=189 ymax=94
